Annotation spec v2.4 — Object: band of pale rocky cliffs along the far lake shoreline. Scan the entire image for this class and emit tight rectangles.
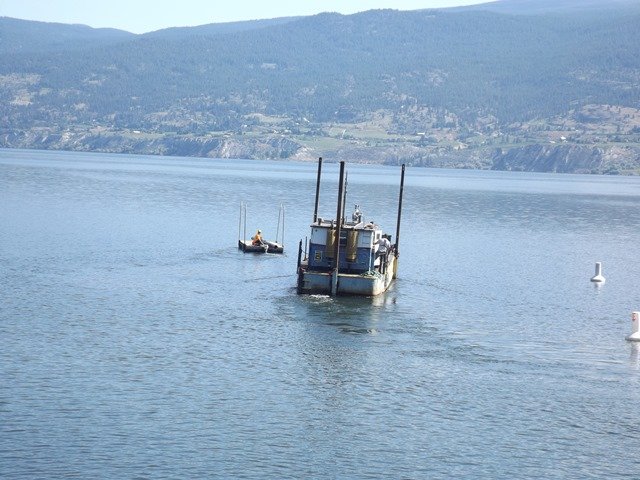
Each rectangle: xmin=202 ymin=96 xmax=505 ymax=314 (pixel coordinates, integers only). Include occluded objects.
xmin=5 ymin=131 xmax=640 ymax=174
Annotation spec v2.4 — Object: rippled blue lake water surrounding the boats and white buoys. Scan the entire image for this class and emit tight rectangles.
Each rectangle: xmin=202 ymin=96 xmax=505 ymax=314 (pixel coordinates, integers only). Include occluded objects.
xmin=0 ymin=150 xmax=640 ymax=479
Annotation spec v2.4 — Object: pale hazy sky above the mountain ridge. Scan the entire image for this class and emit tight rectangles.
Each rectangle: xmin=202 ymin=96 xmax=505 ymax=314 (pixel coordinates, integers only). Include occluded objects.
xmin=0 ymin=0 xmax=491 ymax=33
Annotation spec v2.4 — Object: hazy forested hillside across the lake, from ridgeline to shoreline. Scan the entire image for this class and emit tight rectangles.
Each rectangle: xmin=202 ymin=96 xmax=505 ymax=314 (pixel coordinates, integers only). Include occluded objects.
xmin=0 ymin=0 xmax=640 ymax=173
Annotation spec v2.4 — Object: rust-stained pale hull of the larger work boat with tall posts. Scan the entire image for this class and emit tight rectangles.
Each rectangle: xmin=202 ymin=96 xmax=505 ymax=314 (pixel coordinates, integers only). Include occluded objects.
xmin=298 ymin=254 xmax=396 ymax=297
